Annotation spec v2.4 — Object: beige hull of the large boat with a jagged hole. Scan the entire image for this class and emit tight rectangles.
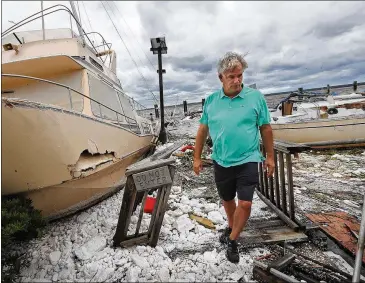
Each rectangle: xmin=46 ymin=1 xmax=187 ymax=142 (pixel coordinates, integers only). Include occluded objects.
xmin=2 ymin=100 xmax=157 ymax=219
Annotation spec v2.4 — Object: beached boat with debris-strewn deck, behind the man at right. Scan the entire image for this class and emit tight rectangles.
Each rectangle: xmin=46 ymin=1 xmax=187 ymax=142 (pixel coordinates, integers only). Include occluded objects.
xmin=271 ymin=92 xmax=365 ymax=146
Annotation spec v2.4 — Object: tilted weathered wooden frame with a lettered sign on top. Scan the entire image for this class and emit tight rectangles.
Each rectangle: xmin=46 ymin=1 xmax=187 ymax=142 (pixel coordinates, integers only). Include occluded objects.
xmin=113 ymin=159 xmax=175 ymax=247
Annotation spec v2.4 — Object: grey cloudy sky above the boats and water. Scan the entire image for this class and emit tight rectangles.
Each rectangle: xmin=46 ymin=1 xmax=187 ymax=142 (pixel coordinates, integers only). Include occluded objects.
xmin=2 ymin=1 xmax=365 ymax=106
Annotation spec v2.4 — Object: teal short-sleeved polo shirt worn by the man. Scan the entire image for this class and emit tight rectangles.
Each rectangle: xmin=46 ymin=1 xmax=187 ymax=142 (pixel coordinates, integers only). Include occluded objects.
xmin=200 ymin=86 xmax=270 ymax=167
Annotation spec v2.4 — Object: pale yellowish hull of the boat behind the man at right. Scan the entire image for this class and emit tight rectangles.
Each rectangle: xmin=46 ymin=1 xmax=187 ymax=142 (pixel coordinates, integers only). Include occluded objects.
xmin=271 ymin=117 xmax=365 ymax=143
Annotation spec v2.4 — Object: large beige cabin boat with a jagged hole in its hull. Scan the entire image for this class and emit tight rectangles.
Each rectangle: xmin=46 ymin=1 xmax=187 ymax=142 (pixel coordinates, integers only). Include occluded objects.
xmin=1 ymin=2 xmax=160 ymax=219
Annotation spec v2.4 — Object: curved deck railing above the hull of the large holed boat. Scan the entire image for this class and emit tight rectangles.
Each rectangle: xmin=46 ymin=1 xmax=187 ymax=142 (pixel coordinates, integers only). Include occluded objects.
xmin=1 ymin=74 xmax=153 ymax=134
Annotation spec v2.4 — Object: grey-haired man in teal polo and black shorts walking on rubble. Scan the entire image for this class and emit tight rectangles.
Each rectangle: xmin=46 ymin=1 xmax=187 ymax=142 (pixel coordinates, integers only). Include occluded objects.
xmin=193 ymin=52 xmax=275 ymax=263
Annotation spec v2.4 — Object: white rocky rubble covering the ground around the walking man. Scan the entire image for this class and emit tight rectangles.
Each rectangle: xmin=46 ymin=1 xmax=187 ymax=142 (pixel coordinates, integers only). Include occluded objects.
xmin=3 ymin=118 xmax=365 ymax=282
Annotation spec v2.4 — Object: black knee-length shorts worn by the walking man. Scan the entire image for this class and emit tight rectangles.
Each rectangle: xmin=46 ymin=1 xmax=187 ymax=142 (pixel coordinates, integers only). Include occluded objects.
xmin=213 ymin=160 xmax=259 ymax=202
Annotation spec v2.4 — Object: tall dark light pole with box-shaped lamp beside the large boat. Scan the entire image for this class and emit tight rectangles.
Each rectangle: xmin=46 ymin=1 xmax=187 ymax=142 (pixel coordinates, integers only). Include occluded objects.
xmin=150 ymin=37 xmax=167 ymax=144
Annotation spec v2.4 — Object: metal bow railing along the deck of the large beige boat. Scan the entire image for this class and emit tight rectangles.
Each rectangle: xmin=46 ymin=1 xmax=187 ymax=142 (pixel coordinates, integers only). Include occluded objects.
xmin=1 ymin=74 xmax=153 ymax=134
